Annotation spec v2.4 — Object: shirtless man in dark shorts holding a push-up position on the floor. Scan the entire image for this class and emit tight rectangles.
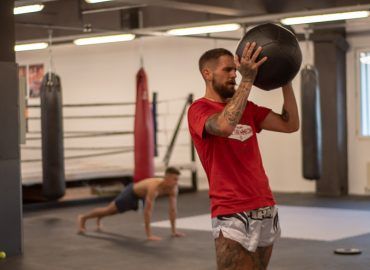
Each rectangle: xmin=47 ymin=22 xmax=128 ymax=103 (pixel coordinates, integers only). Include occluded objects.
xmin=77 ymin=167 xmax=184 ymax=241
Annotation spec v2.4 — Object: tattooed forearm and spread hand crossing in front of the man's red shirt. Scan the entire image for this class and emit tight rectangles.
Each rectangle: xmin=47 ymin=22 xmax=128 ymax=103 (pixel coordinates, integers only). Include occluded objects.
xmin=205 ymin=42 xmax=267 ymax=137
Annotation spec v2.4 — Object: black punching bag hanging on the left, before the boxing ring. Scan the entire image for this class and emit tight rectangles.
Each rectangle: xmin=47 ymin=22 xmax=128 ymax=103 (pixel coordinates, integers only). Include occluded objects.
xmin=40 ymin=73 xmax=65 ymax=200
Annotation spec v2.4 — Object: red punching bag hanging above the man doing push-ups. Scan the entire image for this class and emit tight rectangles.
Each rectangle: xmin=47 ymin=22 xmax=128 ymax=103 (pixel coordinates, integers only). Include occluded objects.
xmin=134 ymin=68 xmax=154 ymax=182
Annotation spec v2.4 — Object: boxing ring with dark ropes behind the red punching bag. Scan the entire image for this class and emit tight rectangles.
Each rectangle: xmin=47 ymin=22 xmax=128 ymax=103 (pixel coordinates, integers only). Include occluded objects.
xmin=21 ymin=93 xmax=197 ymax=200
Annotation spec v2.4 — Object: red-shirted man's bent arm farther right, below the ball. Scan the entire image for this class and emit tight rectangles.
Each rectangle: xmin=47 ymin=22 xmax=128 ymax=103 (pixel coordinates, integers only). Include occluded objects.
xmin=261 ymin=83 xmax=299 ymax=133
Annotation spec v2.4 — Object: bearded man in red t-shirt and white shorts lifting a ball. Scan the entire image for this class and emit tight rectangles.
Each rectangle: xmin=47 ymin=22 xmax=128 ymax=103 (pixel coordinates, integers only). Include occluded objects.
xmin=188 ymin=42 xmax=299 ymax=270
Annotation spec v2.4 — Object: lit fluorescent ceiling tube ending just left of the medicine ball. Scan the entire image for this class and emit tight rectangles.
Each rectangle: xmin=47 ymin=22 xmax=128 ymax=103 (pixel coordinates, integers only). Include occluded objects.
xmin=166 ymin=23 xmax=240 ymax=36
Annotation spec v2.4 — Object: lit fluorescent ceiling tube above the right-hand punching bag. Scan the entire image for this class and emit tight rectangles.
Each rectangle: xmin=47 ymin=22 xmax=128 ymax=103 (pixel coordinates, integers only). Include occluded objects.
xmin=281 ymin=10 xmax=370 ymax=25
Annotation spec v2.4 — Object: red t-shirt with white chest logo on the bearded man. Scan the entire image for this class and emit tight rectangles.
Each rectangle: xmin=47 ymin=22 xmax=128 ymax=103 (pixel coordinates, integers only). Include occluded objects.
xmin=188 ymin=98 xmax=275 ymax=217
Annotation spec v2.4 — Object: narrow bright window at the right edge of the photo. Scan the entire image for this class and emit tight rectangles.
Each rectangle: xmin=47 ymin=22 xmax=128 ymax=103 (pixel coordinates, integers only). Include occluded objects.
xmin=360 ymin=52 xmax=370 ymax=136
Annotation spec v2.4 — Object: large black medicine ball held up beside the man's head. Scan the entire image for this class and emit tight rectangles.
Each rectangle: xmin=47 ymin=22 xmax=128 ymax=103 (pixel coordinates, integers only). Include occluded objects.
xmin=236 ymin=23 xmax=302 ymax=90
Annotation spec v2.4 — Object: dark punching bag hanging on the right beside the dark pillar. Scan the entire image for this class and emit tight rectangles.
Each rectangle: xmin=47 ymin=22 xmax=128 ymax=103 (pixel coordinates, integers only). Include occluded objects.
xmin=301 ymin=65 xmax=322 ymax=180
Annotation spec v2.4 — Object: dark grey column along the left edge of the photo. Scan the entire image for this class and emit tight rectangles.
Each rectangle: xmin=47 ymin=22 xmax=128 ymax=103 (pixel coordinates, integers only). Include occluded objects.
xmin=0 ymin=0 xmax=23 ymax=256
